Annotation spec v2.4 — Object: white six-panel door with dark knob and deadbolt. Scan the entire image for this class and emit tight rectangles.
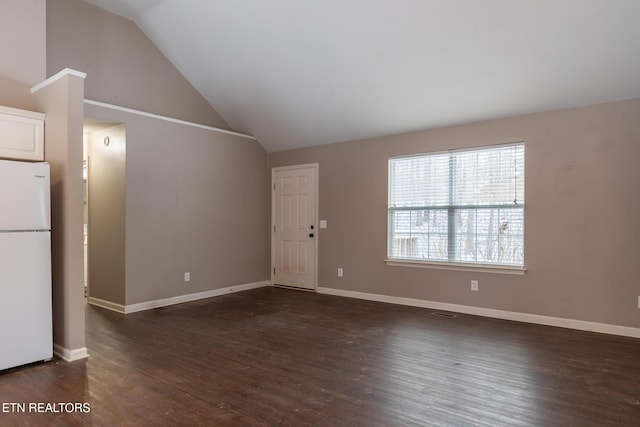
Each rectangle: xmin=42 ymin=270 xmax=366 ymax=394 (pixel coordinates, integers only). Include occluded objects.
xmin=271 ymin=164 xmax=318 ymax=289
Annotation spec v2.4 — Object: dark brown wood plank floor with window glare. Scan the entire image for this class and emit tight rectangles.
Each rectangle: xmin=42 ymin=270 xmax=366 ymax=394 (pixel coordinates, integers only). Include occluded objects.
xmin=0 ymin=288 xmax=640 ymax=426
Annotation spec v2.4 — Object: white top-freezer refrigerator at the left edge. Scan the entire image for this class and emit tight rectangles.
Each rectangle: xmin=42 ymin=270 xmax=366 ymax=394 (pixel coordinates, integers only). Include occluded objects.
xmin=0 ymin=160 xmax=53 ymax=370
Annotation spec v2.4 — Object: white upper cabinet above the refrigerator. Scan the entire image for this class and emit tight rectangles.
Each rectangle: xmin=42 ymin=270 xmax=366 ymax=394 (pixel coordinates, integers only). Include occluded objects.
xmin=0 ymin=106 xmax=44 ymax=161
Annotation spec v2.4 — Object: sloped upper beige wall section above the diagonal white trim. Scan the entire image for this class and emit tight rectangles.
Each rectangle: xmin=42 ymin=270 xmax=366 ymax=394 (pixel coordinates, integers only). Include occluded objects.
xmin=48 ymin=0 xmax=229 ymax=129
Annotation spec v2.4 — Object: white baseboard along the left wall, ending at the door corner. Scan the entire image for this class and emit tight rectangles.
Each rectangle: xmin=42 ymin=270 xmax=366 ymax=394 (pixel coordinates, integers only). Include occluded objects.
xmin=87 ymin=280 xmax=271 ymax=314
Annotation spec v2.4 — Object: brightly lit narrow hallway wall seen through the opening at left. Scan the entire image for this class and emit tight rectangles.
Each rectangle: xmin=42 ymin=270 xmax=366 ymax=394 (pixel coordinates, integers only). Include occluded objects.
xmin=87 ymin=125 xmax=126 ymax=305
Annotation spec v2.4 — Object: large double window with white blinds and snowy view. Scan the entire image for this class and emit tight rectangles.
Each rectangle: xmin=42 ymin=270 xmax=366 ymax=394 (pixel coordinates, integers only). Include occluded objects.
xmin=388 ymin=143 xmax=524 ymax=267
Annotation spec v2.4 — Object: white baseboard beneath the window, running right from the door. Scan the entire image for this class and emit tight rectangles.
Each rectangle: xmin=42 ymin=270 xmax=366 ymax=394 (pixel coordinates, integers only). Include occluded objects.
xmin=317 ymin=287 xmax=640 ymax=338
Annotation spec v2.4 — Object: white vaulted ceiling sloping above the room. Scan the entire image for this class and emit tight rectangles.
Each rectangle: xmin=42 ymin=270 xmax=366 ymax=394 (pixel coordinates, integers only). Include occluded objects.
xmin=80 ymin=0 xmax=640 ymax=152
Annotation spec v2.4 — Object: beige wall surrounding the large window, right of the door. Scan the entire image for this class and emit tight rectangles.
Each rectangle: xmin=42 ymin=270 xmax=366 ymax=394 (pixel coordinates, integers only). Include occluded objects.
xmin=269 ymin=99 xmax=640 ymax=327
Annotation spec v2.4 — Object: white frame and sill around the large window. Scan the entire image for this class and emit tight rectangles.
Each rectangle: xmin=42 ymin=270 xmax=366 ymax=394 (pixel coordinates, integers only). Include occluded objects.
xmin=385 ymin=141 xmax=526 ymax=275
